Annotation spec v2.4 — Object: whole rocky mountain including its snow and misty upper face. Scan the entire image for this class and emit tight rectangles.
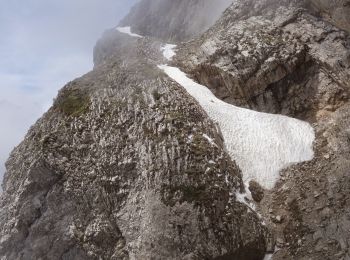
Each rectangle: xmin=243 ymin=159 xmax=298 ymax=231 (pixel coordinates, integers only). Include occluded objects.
xmin=0 ymin=0 xmax=350 ymax=260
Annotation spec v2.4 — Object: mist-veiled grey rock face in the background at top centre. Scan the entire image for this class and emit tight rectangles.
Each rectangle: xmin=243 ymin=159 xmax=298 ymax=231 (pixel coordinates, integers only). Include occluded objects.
xmin=121 ymin=0 xmax=232 ymax=41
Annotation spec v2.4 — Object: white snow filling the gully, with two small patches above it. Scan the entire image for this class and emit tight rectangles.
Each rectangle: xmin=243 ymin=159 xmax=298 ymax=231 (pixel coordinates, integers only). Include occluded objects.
xmin=117 ymin=27 xmax=315 ymax=189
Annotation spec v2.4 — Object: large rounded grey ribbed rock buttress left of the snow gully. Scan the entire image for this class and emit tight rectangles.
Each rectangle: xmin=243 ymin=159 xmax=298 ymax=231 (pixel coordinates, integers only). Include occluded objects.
xmin=0 ymin=26 xmax=267 ymax=260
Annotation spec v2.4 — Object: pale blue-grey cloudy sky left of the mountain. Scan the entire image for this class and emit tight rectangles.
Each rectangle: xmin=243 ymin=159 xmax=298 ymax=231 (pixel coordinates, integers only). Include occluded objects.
xmin=0 ymin=0 xmax=136 ymax=185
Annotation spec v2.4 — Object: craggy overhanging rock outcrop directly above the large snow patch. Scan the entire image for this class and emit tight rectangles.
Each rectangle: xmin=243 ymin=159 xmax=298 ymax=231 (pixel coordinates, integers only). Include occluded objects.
xmin=177 ymin=0 xmax=350 ymax=118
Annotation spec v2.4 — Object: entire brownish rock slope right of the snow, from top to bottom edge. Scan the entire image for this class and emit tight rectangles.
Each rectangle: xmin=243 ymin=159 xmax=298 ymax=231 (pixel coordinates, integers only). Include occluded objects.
xmin=174 ymin=0 xmax=350 ymax=260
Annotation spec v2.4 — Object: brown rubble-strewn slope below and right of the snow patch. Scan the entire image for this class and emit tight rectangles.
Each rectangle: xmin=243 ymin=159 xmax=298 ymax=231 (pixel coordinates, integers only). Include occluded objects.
xmin=260 ymin=103 xmax=350 ymax=260
